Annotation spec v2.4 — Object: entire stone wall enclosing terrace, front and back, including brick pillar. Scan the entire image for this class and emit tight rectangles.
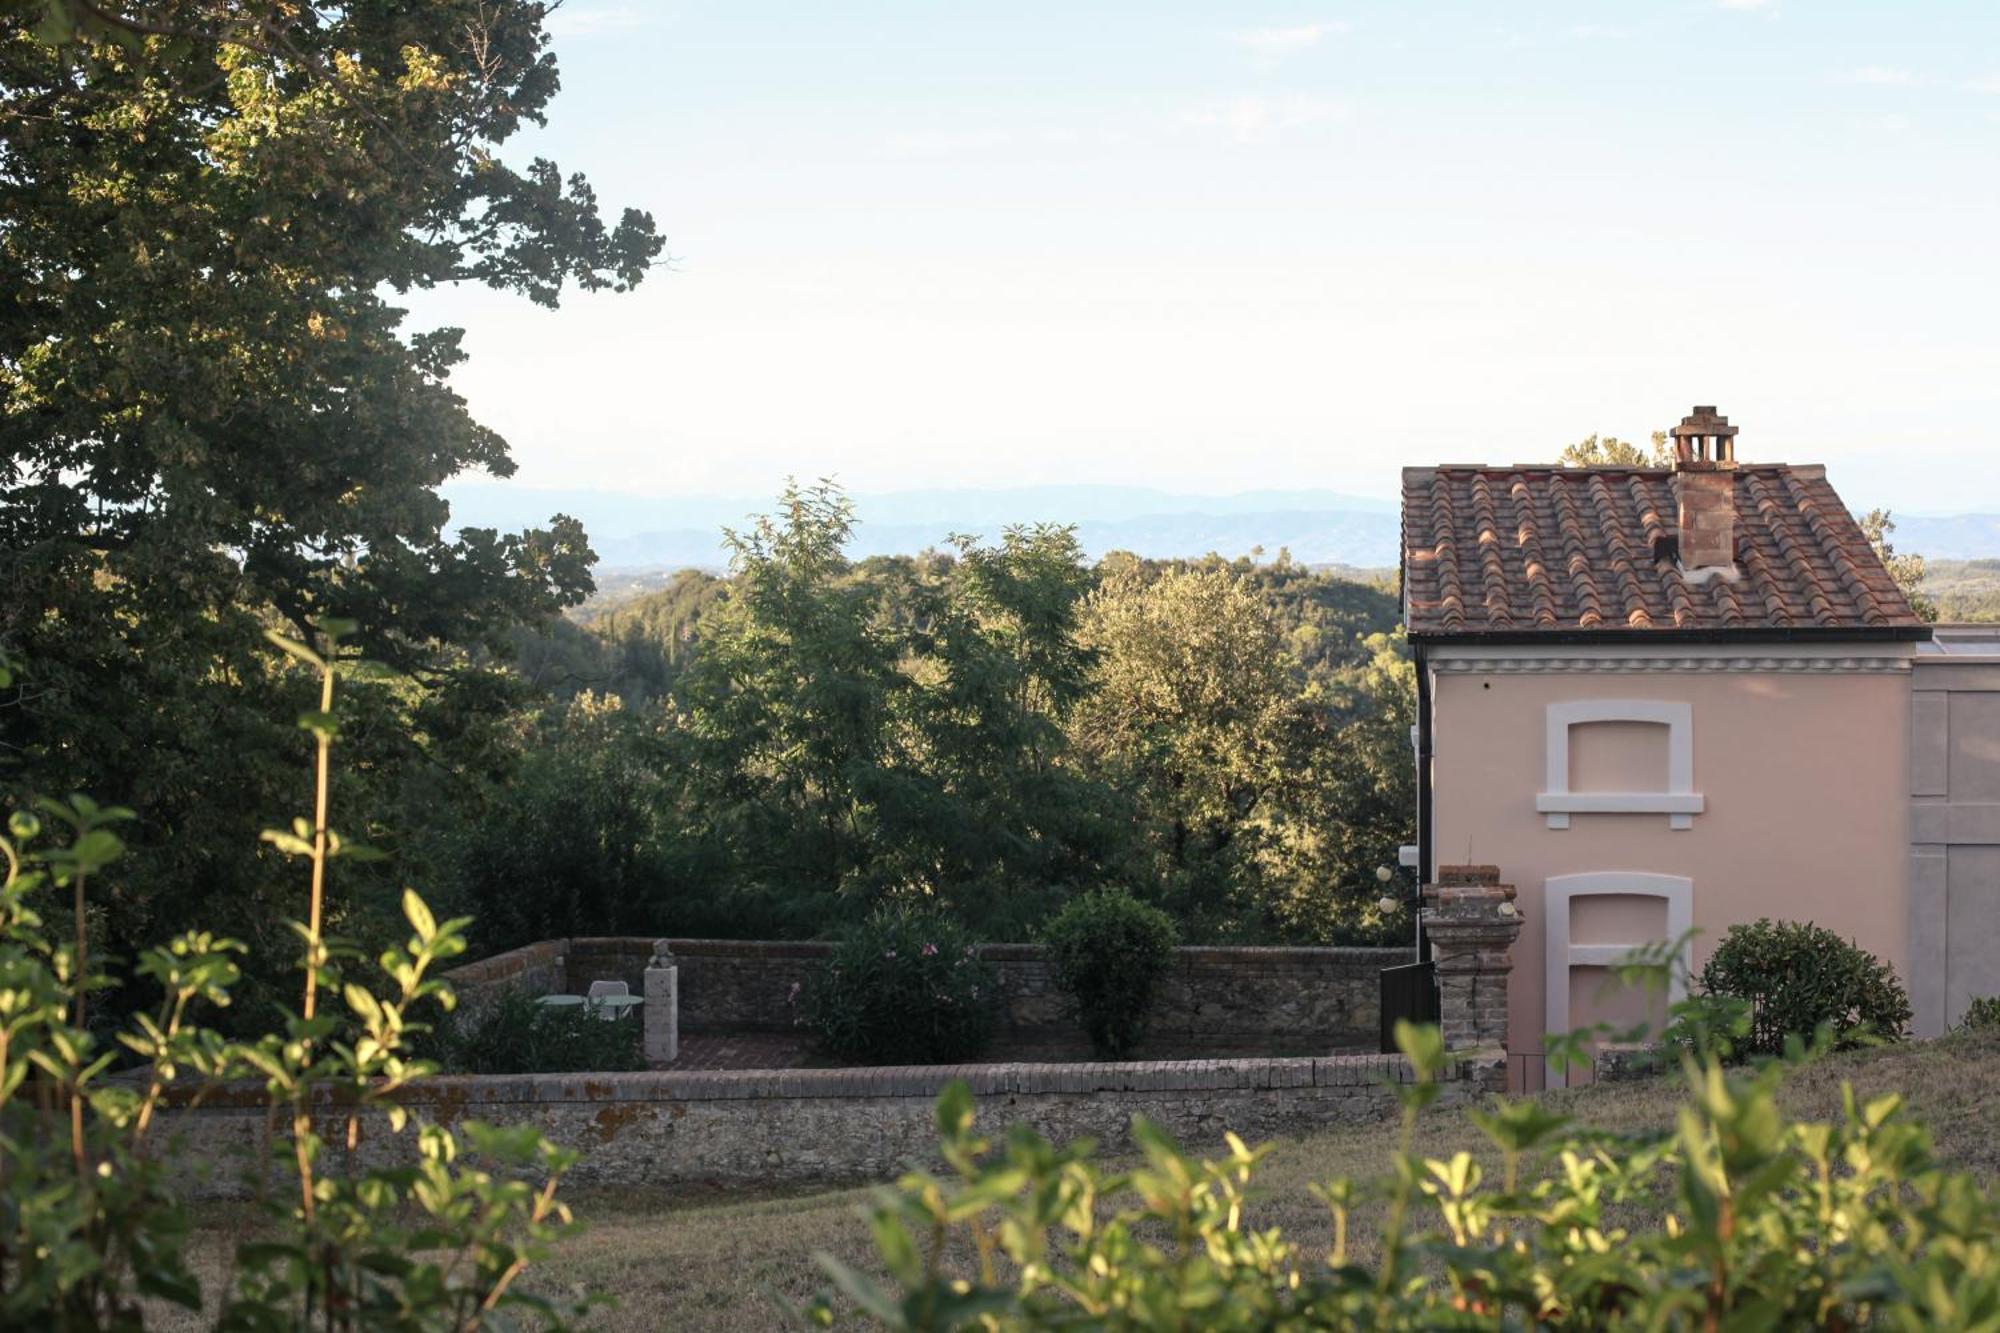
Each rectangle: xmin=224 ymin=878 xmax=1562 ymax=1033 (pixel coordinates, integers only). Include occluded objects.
xmin=162 ymin=867 xmax=1520 ymax=1195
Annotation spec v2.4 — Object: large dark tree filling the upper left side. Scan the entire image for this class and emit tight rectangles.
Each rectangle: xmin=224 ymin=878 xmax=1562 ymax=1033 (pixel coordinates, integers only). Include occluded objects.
xmin=0 ymin=0 xmax=660 ymax=1008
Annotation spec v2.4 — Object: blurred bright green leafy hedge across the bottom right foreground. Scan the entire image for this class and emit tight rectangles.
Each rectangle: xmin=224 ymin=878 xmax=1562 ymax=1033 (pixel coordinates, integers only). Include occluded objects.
xmin=808 ymin=1023 xmax=2000 ymax=1333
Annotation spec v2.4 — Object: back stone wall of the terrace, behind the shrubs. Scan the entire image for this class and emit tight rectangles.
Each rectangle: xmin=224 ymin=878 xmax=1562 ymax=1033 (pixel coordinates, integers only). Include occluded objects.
xmin=448 ymin=939 xmax=1410 ymax=1049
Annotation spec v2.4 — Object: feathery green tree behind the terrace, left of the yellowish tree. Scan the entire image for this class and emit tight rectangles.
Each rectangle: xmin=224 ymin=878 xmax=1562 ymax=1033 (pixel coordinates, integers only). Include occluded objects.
xmin=676 ymin=486 xmax=1136 ymax=931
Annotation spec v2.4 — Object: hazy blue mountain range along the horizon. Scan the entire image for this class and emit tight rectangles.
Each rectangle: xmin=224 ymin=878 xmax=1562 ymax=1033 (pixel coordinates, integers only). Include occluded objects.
xmin=444 ymin=482 xmax=2000 ymax=570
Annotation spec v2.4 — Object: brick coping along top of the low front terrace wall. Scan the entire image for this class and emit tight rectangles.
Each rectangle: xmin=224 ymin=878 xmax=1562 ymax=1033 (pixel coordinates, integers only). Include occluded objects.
xmin=156 ymin=1055 xmax=1440 ymax=1121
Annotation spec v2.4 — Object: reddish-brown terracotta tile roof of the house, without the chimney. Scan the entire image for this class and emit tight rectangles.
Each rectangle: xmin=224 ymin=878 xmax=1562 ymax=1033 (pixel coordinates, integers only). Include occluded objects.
xmin=1402 ymin=464 xmax=1928 ymax=638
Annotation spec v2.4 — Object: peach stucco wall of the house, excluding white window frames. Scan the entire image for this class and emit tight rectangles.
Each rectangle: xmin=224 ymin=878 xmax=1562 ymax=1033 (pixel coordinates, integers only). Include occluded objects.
xmin=1432 ymin=671 xmax=1910 ymax=1053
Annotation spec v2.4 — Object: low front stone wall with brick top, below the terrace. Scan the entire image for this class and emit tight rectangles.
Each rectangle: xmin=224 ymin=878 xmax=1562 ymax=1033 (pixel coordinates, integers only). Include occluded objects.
xmin=162 ymin=1055 xmax=1490 ymax=1197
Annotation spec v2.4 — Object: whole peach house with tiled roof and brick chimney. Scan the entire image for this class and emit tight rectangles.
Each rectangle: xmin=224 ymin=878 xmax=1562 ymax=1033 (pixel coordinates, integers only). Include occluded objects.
xmin=1402 ymin=406 xmax=1944 ymax=1053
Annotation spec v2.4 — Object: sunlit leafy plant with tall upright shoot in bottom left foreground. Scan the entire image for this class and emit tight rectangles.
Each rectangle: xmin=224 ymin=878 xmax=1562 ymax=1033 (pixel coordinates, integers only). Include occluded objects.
xmin=0 ymin=622 xmax=574 ymax=1333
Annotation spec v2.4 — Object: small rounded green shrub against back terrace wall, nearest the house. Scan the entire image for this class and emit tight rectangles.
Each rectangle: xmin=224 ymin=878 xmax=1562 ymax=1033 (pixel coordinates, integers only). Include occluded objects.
xmin=1042 ymin=889 xmax=1180 ymax=1059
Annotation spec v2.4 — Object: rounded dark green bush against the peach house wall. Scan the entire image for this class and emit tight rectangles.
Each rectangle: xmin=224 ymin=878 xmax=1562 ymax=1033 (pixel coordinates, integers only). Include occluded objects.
xmin=1700 ymin=919 xmax=1910 ymax=1055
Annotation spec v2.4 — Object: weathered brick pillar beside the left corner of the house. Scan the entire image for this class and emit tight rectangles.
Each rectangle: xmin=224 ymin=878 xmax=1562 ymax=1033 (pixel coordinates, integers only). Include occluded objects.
xmin=1424 ymin=865 xmax=1522 ymax=1091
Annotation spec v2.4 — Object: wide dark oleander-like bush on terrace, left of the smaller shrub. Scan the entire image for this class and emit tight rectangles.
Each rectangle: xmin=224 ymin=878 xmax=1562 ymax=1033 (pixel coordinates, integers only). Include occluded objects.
xmin=796 ymin=905 xmax=1000 ymax=1065
